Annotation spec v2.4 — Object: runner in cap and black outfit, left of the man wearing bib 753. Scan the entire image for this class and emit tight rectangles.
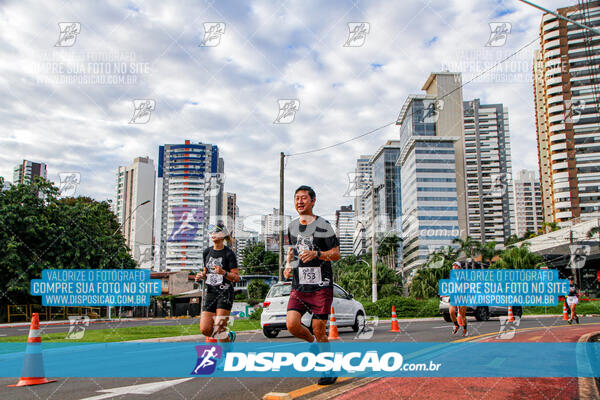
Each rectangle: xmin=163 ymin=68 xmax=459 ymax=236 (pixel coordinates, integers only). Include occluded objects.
xmin=196 ymin=223 xmax=240 ymax=342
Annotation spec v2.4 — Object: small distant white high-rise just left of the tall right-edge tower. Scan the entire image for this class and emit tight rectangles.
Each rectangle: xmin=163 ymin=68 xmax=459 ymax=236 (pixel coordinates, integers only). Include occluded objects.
xmin=513 ymin=169 xmax=544 ymax=237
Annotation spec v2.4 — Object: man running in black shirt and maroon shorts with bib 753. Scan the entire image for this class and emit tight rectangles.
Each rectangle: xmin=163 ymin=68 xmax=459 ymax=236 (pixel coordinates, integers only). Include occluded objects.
xmin=283 ymin=186 xmax=340 ymax=385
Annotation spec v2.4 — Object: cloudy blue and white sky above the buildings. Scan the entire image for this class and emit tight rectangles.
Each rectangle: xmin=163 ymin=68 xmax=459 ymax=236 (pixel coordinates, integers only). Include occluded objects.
xmin=0 ymin=0 xmax=574 ymax=225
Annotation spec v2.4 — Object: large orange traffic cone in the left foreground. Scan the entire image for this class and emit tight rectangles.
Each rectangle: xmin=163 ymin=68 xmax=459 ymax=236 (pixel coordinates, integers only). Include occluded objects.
xmin=8 ymin=313 xmax=56 ymax=387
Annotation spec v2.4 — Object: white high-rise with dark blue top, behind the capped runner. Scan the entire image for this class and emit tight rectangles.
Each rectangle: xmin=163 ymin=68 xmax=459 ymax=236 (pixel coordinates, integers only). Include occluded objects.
xmin=156 ymin=140 xmax=223 ymax=271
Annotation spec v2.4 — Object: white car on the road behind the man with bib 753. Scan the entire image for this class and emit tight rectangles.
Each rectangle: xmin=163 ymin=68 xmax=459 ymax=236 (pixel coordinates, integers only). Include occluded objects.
xmin=260 ymin=282 xmax=365 ymax=338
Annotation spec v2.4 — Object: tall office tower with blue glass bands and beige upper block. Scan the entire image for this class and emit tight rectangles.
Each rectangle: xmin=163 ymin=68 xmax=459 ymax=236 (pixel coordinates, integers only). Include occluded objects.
xmin=397 ymin=72 xmax=467 ymax=274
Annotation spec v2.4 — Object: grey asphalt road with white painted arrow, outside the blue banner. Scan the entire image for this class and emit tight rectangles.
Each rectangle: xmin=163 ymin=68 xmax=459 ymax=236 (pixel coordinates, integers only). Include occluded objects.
xmin=0 ymin=317 xmax=600 ymax=400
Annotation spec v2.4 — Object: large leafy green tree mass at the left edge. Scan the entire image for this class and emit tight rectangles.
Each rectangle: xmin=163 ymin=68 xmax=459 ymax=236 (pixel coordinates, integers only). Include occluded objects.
xmin=0 ymin=178 xmax=135 ymax=313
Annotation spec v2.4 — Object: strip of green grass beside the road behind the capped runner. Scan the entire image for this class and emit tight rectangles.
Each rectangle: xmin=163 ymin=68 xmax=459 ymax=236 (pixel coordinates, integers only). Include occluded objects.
xmin=0 ymin=319 xmax=260 ymax=343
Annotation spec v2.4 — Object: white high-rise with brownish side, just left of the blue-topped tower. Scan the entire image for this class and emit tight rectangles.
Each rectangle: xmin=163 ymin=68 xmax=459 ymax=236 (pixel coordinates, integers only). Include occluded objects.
xmin=112 ymin=157 xmax=156 ymax=268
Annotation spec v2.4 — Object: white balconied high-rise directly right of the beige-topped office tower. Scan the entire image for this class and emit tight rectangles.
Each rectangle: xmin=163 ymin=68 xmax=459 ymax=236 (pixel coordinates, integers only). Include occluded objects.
xmin=464 ymin=99 xmax=515 ymax=244
